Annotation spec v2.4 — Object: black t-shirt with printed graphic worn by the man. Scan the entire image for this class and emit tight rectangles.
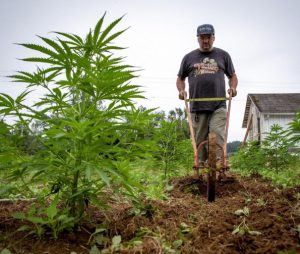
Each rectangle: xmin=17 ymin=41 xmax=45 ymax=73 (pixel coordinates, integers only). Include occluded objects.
xmin=178 ymin=48 xmax=235 ymax=112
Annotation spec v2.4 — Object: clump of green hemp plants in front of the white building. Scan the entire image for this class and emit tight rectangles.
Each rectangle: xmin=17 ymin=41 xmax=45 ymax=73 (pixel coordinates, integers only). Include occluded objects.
xmin=230 ymin=124 xmax=300 ymax=187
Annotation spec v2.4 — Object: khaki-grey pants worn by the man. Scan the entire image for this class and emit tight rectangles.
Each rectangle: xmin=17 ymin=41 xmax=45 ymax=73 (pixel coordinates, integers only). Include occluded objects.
xmin=191 ymin=108 xmax=227 ymax=162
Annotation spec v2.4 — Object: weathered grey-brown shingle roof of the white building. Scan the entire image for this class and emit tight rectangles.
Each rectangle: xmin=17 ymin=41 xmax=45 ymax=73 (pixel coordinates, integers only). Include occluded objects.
xmin=242 ymin=93 xmax=300 ymax=128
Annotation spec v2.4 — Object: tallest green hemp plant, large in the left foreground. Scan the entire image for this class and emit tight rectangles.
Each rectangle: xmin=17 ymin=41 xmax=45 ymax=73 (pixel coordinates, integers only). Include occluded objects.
xmin=0 ymin=14 xmax=151 ymax=220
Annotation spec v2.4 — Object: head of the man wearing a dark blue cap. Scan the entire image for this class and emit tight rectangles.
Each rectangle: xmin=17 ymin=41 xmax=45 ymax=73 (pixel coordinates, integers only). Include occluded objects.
xmin=197 ymin=24 xmax=215 ymax=52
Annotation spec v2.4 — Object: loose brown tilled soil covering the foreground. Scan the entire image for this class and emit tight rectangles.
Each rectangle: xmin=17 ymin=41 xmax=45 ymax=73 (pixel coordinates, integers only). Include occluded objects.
xmin=0 ymin=176 xmax=300 ymax=254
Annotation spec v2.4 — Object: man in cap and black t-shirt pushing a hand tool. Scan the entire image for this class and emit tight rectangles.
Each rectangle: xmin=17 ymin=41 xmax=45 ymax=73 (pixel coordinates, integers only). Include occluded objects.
xmin=176 ymin=24 xmax=238 ymax=165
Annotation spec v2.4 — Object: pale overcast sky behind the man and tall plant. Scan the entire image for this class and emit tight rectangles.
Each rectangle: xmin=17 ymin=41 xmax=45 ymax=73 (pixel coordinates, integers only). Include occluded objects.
xmin=0 ymin=0 xmax=300 ymax=141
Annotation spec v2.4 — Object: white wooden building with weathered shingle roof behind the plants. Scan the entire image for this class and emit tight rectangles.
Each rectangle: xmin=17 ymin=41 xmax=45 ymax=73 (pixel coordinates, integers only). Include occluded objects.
xmin=242 ymin=93 xmax=300 ymax=142
